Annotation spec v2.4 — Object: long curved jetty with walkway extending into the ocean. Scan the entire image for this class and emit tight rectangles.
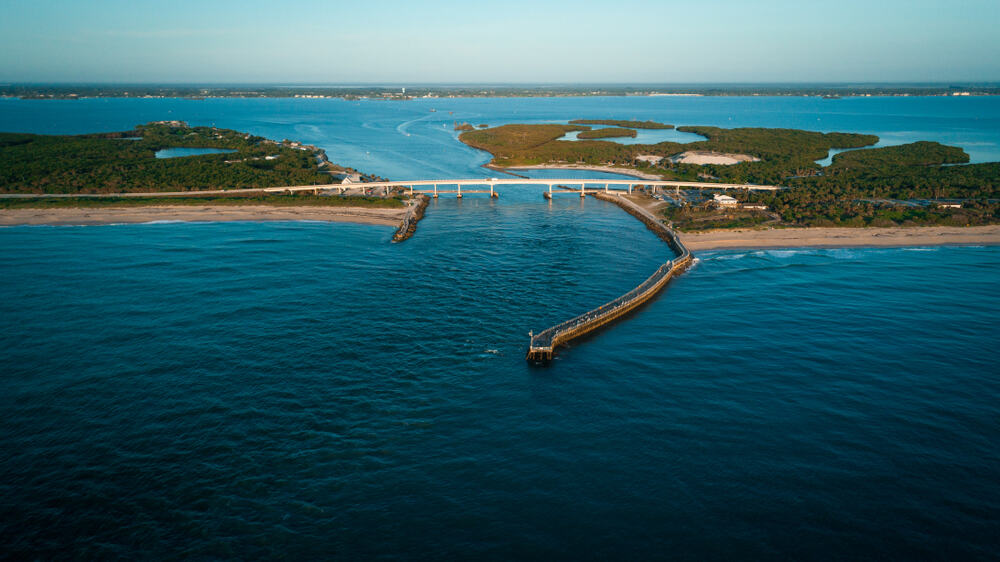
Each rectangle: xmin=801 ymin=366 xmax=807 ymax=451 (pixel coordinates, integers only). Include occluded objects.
xmin=527 ymin=193 xmax=692 ymax=362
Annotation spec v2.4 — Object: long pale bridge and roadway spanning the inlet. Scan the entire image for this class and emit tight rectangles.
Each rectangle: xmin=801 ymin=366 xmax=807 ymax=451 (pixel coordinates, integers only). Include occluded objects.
xmin=0 ymin=178 xmax=782 ymax=199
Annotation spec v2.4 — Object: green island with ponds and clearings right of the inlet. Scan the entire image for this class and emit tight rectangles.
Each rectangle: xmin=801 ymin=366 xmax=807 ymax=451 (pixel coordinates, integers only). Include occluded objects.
xmin=459 ymin=120 xmax=1000 ymax=232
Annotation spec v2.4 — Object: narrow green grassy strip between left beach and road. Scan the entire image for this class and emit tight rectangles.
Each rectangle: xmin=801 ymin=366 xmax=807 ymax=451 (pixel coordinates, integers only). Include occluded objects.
xmin=0 ymin=194 xmax=405 ymax=209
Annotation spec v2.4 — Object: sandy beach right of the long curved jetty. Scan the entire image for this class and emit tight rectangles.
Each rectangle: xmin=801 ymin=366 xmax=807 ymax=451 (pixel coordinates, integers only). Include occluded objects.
xmin=680 ymin=225 xmax=1000 ymax=251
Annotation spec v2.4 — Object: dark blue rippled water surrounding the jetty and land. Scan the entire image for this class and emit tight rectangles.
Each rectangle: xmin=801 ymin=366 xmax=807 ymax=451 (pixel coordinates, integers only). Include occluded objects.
xmin=0 ymin=98 xmax=1000 ymax=560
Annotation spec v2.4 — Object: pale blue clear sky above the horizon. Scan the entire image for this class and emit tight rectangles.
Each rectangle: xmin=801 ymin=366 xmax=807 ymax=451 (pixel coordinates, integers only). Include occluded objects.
xmin=0 ymin=0 xmax=1000 ymax=83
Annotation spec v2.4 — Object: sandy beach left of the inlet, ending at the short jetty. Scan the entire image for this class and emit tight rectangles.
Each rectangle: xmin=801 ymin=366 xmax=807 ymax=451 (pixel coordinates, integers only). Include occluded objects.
xmin=0 ymin=205 xmax=406 ymax=226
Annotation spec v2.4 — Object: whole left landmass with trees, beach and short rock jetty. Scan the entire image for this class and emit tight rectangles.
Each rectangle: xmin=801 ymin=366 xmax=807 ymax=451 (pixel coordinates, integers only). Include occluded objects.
xmin=0 ymin=121 xmax=427 ymax=240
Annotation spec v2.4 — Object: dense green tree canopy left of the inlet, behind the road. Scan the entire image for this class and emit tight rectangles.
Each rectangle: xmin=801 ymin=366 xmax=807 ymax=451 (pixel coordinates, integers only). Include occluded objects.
xmin=0 ymin=123 xmax=334 ymax=193
